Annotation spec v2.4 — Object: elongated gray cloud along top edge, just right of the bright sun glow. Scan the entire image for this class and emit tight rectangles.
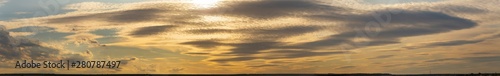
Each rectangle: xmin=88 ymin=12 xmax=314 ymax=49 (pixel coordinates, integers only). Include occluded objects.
xmin=211 ymin=0 xmax=349 ymax=19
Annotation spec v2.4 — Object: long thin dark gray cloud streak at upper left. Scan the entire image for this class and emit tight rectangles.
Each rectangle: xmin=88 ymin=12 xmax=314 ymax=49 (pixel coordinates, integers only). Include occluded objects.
xmin=47 ymin=8 xmax=166 ymax=23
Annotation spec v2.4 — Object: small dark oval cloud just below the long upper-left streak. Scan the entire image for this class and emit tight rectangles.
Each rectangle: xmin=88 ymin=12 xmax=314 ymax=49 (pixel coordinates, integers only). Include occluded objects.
xmin=129 ymin=25 xmax=176 ymax=37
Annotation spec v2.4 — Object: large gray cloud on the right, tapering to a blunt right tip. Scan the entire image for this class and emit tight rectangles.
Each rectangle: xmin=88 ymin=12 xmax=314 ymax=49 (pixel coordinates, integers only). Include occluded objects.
xmin=299 ymin=11 xmax=477 ymax=48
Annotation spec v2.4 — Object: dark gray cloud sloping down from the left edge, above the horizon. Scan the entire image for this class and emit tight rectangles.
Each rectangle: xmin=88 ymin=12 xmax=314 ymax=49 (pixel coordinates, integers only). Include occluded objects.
xmin=0 ymin=26 xmax=92 ymax=61
